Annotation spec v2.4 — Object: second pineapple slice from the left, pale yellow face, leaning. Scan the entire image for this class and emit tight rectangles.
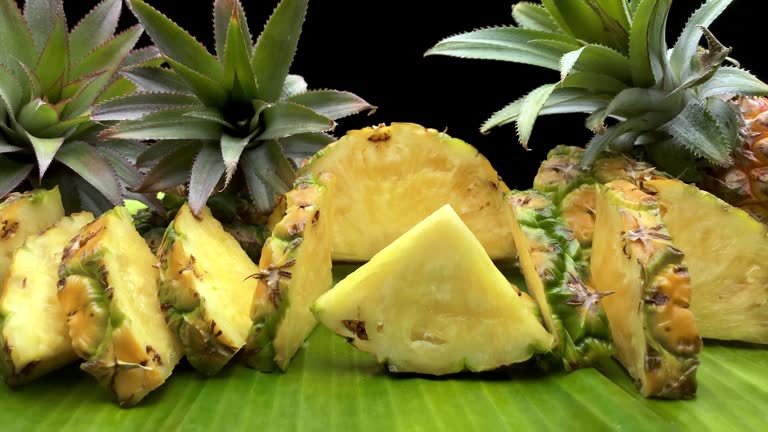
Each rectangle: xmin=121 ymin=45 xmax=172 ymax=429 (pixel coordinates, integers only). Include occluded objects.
xmin=0 ymin=213 xmax=93 ymax=386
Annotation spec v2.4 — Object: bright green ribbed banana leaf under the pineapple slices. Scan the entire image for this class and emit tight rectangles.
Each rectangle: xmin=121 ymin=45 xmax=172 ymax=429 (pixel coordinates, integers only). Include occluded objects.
xmin=0 ymin=266 xmax=768 ymax=432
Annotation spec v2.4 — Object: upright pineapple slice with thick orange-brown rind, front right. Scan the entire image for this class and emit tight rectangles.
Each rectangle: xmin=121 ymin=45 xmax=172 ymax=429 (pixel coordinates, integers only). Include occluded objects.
xmin=591 ymin=180 xmax=701 ymax=399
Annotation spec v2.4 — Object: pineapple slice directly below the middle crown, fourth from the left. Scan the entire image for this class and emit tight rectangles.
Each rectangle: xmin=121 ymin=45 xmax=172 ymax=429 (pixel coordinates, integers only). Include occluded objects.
xmin=160 ymin=204 xmax=259 ymax=375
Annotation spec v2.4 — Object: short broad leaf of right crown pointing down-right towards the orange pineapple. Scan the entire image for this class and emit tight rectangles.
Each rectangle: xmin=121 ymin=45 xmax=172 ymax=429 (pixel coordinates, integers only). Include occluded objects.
xmin=661 ymin=101 xmax=733 ymax=167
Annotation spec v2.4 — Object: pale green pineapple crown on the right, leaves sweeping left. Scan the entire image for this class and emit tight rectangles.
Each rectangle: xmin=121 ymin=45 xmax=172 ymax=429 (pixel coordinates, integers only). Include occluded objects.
xmin=427 ymin=0 xmax=768 ymax=178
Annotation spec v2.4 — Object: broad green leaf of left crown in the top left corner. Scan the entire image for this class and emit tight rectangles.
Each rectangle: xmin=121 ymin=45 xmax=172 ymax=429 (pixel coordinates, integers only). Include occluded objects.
xmin=0 ymin=0 xmax=37 ymax=66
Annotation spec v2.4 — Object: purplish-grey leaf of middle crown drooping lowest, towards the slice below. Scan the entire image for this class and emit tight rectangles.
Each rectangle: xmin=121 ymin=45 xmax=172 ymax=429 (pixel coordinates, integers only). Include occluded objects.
xmin=188 ymin=143 xmax=225 ymax=215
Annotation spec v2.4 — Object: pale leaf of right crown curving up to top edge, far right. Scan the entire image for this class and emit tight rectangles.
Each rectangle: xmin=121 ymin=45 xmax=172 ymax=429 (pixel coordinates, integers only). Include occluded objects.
xmin=669 ymin=0 xmax=733 ymax=81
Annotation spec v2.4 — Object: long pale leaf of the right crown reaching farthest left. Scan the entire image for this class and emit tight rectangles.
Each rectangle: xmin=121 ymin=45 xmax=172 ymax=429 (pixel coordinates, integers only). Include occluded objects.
xmin=425 ymin=26 xmax=579 ymax=71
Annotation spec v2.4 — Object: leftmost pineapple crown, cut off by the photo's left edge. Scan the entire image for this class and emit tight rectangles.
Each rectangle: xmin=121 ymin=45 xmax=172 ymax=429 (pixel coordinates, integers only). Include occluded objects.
xmin=0 ymin=0 xmax=161 ymax=213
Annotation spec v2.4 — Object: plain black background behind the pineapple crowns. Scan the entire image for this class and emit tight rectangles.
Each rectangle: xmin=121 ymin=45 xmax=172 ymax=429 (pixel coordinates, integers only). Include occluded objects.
xmin=27 ymin=0 xmax=768 ymax=188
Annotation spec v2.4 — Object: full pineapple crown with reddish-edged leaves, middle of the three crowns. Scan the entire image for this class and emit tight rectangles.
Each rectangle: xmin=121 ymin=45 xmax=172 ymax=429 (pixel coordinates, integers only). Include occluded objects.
xmin=99 ymin=0 xmax=373 ymax=215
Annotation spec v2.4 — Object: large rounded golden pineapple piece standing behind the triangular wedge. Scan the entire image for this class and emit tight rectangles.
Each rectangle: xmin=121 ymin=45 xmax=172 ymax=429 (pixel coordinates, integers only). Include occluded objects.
xmin=300 ymin=123 xmax=515 ymax=261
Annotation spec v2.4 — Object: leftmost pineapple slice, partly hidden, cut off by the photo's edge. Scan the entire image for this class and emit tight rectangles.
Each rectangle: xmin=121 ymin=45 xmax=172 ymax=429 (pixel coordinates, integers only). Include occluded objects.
xmin=0 ymin=188 xmax=64 ymax=283
